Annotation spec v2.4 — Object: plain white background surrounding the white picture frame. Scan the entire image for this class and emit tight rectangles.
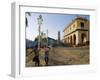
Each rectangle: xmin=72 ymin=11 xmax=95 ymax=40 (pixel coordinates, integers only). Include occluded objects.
xmin=0 ymin=0 xmax=100 ymax=80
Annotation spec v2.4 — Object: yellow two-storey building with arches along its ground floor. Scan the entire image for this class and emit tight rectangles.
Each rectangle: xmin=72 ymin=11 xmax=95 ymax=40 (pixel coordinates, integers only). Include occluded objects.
xmin=63 ymin=17 xmax=89 ymax=45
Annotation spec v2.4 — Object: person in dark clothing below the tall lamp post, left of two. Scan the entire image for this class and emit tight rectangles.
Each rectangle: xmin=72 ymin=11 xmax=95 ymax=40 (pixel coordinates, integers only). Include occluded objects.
xmin=33 ymin=45 xmax=40 ymax=66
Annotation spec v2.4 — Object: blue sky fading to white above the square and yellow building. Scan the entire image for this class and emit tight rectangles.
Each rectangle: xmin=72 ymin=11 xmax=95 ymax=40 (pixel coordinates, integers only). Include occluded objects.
xmin=25 ymin=12 xmax=89 ymax=41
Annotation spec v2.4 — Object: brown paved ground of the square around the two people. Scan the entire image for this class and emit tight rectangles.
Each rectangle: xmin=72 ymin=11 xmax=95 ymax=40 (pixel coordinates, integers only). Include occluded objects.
xmin=26 ymin=47 xmax=89 ymax=67
